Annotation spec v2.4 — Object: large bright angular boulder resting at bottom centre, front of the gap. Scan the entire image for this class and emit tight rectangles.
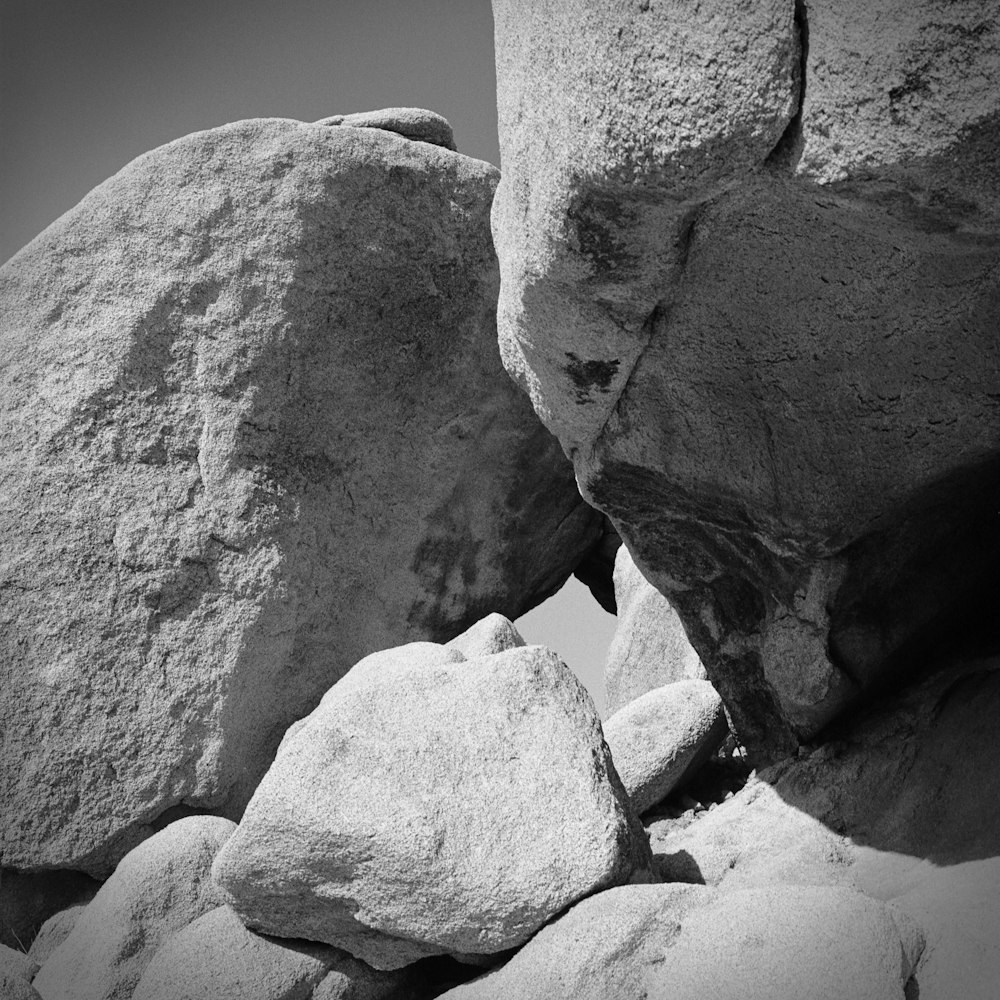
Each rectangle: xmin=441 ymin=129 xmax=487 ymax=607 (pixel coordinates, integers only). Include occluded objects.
xmin=213 ymin=646 xmax=648 ymax=969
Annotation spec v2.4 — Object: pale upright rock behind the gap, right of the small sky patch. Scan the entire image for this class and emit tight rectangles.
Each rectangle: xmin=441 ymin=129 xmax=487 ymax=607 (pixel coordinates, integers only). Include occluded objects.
xmin=604 ymin=545 xmax=705 ymax=715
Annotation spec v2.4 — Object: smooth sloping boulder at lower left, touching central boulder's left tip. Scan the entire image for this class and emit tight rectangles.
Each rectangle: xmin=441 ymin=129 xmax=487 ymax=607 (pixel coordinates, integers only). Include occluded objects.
xmin=34 ymin=816 xmax=236 ymax=1000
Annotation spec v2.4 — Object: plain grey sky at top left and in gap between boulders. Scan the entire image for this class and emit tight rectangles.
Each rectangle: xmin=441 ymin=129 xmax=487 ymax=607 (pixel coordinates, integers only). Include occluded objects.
xmin=0 ymin=0 xmax=615 ymax=711
